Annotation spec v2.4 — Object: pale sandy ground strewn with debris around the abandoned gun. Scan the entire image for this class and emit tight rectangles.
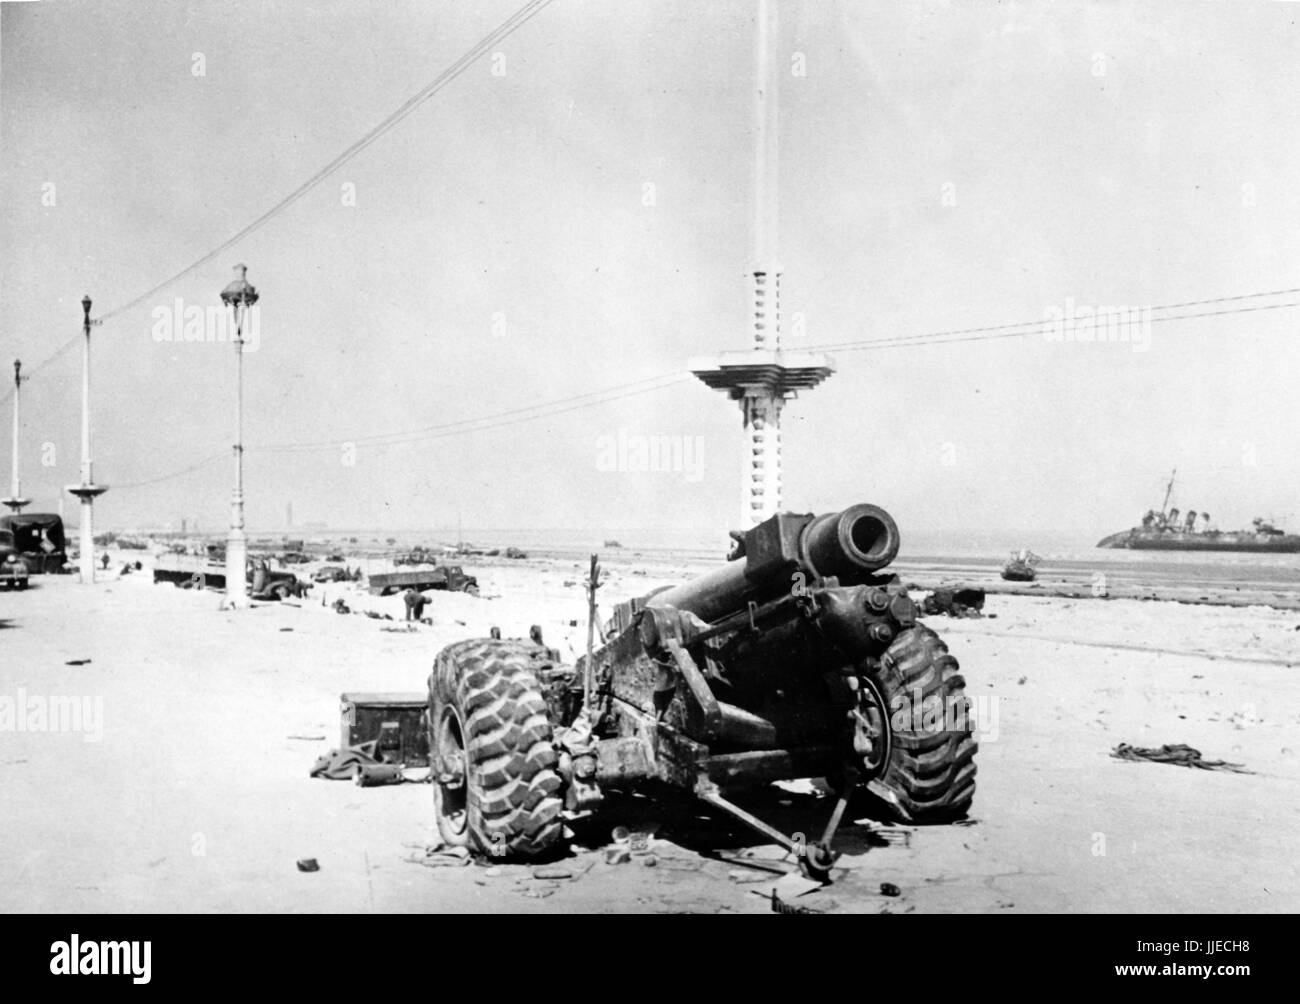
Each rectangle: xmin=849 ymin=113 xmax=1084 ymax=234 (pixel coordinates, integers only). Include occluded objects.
xmin=0 ymin=551 xmax=1300 ymax=913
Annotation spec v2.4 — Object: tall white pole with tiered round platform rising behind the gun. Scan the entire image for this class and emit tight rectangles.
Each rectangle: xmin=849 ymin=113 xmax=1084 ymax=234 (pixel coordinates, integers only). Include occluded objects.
xmin=689 ymin=0 xmax=835 ymax=529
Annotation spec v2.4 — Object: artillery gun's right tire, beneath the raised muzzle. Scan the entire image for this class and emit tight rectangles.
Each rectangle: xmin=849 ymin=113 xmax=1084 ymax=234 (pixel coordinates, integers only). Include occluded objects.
xmin=870 ymin=624 xmax=979 ymax=823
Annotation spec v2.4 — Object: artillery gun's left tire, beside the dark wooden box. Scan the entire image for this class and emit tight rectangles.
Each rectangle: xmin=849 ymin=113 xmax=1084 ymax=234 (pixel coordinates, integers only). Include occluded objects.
xmin=429 ymin=639 xmax=564 ymax=858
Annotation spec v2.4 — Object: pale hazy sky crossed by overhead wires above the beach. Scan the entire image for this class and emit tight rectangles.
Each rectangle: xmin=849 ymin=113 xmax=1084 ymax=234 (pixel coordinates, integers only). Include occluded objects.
xmin=0 ymin=0 xmax=1300 ymax=544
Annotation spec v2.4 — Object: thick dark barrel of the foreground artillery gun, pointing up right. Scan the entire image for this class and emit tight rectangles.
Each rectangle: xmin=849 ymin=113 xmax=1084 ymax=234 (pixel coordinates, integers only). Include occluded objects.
xmin=646 ymin=503 xmax=900 ymax=620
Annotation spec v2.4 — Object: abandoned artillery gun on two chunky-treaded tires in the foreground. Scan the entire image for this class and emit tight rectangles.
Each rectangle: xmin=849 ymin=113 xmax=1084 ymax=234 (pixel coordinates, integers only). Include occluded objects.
xmin=428 ymin=505 xmax=976 ymax=879
